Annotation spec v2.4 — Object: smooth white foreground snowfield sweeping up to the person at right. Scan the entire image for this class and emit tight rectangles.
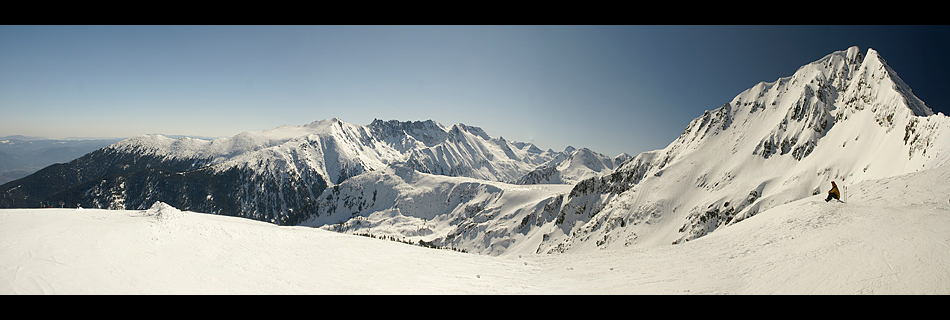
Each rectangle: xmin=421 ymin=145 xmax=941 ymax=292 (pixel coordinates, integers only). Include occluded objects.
xmin=0 ymin=167 xmax=950 ymax=294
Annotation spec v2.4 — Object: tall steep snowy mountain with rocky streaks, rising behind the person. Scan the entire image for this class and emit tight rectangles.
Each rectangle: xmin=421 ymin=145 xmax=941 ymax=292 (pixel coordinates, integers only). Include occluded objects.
xmin=538 ymin=47 xmax=950 ymax=252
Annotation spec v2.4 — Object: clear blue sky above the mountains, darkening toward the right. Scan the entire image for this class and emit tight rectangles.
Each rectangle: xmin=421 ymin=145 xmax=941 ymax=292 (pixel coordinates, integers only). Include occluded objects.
xmin=0 ymin=25 xmax=950 ymax=156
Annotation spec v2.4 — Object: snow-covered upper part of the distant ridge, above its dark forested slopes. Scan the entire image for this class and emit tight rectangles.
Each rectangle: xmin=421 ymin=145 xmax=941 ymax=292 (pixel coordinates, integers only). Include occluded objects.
xmin=102 ymin=118 xmax=580 ymax=185
